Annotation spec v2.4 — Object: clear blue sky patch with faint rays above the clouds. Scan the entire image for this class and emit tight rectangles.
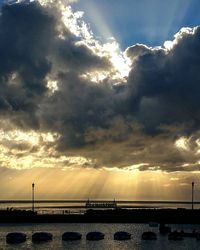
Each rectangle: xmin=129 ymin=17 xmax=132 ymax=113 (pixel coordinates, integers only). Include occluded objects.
xmin=73 ymin=0 xmax=200 ymax=49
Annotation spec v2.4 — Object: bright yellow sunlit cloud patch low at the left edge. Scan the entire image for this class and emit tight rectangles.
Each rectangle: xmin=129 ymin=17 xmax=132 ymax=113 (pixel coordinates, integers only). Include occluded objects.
xmin=0 ymin=129 xmax=93 ymax=170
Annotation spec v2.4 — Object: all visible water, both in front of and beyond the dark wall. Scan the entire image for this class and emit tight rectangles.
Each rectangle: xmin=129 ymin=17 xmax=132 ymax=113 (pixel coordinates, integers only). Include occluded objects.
xmin=0 ymin=201 xmax=200 ymax=250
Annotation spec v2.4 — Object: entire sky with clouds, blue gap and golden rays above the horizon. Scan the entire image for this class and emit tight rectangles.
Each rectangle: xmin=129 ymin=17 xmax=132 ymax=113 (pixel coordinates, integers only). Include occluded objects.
xmin=0 ymin=0 xmax=200 ymax=200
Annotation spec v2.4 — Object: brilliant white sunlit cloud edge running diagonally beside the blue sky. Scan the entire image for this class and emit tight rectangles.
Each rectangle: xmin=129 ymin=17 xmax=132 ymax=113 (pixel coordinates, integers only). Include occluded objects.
xmin=49 ymin=2 xmax=130 ymax=81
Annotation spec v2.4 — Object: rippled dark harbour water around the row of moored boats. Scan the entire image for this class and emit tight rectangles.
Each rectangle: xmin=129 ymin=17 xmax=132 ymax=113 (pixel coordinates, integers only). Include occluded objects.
xmin=0 ymin=223 xmax=200 ymax=250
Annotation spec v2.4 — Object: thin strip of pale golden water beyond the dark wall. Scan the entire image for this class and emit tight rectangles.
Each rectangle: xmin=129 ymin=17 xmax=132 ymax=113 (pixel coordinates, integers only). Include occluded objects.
xmin=0 ymin=199 xmax=200 ymax=212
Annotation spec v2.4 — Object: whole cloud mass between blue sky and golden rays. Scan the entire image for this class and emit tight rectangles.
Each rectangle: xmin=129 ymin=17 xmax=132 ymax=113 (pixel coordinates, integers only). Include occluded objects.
xmin=0 ymin=1 xmax=200 ymax=172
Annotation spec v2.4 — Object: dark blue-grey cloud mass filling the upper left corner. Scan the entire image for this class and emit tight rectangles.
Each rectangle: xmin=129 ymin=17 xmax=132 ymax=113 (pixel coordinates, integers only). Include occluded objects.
xmin=0 ymin=3 xmax=55 ymax=128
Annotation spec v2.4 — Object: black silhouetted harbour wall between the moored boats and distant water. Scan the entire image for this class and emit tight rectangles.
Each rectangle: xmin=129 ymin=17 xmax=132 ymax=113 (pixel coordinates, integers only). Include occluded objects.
xmin=0 ymin=209 xmax=200 ymax=224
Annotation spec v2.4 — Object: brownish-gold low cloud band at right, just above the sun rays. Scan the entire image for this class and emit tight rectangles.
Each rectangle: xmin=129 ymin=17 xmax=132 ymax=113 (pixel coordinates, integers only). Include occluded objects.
xmin=74 ymin=127 xmax=199 ymax=172
